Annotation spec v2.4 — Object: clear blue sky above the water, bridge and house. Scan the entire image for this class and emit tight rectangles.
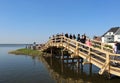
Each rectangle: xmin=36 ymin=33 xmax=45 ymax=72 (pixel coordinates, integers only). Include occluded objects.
xmin=0 ymin=0 xmax=120 ymax=44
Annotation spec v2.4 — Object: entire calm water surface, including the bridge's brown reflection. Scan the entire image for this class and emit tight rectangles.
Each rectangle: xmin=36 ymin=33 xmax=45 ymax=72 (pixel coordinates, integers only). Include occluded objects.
xmin=0 ymin=44 xmax=120 ymax=83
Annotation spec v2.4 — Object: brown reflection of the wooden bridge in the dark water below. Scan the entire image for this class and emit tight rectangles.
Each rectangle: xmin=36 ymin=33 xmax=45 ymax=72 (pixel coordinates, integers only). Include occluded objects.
xmin=39 ymin=54 xmax=120 ymax=83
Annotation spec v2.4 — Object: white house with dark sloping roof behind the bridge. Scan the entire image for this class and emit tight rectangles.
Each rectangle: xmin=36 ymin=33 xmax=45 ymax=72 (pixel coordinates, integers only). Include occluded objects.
xmin=102 ymin=27 xmax=120 ymax=43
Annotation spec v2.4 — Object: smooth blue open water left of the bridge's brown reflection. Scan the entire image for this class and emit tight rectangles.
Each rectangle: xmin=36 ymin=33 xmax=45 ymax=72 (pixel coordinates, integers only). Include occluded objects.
xmin=0 ymin=45 xmax=55 ymax=83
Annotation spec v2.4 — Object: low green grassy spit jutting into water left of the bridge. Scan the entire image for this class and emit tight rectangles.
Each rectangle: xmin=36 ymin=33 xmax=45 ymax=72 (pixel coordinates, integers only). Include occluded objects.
xmin=9 ymin=48 xmax=44 ymax=56
